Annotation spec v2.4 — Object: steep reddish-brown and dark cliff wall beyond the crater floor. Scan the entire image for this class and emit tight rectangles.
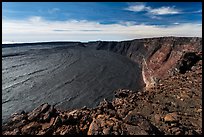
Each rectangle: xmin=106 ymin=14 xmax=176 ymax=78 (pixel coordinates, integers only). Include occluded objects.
xmin=87 ymin=37 xmax=202 ymax=87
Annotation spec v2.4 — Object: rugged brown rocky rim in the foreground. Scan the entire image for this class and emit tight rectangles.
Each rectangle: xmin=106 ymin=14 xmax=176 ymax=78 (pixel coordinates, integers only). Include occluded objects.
xmin=2 ymin=52 xmax=202 ymax=135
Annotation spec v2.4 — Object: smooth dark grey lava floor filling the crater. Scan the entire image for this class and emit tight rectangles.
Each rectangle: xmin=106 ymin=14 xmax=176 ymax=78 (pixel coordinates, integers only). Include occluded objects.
xmin=2 ymin=43 xmax=143 ymax=122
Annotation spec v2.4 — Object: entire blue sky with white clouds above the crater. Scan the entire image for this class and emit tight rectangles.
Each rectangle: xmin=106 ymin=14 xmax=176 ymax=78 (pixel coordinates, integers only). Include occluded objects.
xmin=2 ymin=2 xmax=202 ymax=43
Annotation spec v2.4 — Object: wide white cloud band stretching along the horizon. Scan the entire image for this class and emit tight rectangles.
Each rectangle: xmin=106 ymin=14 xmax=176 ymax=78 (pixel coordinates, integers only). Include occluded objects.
xmin=2 ymin=16 xmax=202 ymax=42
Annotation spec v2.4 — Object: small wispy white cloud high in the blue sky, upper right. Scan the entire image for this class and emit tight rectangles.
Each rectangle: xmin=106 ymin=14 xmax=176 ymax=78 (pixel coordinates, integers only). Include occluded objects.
xmin=125 ymin=3 xmax=181 ymax=15
